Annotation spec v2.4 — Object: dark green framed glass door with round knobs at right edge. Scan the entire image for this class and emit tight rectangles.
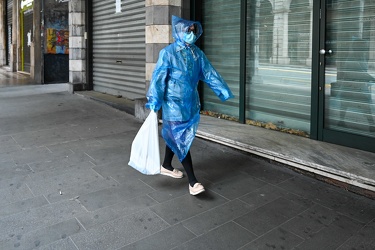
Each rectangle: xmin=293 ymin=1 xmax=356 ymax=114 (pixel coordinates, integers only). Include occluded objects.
xmin=318 ymin=0 xmax=375 ymax=152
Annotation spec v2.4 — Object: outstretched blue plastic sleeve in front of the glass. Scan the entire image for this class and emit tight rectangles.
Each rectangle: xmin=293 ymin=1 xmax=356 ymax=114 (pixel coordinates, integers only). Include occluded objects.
xmin=200 ymin=53 xmax=234 ymax=101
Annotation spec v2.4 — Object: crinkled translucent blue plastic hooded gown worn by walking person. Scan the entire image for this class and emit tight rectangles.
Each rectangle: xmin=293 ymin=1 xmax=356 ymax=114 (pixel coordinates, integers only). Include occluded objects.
xmin=146 ymin=16 xmax=233 ymax=161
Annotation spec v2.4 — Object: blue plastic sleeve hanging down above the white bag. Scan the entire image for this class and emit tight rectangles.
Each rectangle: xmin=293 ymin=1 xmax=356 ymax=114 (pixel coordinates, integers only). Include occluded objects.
xmin=145 ymin=50 xmax=169 ymax=111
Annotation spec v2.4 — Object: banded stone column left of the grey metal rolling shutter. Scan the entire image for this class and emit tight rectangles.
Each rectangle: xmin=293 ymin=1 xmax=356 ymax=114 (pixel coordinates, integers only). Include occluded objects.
xmin=69 ymin=0 xmax=89 ymax=93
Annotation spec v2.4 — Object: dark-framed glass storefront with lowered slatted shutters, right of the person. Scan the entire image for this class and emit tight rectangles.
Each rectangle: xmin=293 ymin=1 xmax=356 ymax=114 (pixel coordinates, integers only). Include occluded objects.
xmin=192 ymin=0 xmax=375 ymax=152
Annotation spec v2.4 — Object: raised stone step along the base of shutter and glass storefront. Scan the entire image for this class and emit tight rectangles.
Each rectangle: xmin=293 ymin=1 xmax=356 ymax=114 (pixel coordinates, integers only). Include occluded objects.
xmin=78 ymin=91 xmax=375 ymax=198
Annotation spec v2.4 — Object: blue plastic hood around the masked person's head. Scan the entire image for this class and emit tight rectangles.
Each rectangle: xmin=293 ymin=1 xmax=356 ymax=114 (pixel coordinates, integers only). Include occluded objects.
xmin=172 ymin=16 xmax=203 ymax=45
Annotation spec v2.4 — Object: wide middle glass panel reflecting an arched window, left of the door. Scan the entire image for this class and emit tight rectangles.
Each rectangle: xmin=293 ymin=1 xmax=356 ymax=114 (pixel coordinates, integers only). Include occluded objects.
xmin=246 ymin=0 xmax=312 ymax=136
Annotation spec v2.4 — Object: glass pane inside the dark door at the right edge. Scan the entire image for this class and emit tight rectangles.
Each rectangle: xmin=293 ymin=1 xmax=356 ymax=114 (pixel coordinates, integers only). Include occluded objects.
xmin=325 ymin=0 xmax=375 ymax=137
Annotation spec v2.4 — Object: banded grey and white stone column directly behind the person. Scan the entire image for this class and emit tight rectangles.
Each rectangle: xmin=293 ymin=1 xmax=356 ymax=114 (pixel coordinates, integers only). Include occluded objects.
xmin=135 ymin=0 xmax=182 ymax=119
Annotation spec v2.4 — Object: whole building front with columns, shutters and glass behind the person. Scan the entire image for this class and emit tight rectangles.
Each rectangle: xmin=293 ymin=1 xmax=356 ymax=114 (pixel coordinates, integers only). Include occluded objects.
xmin=0 ymin=0 xmax=375 ymax=152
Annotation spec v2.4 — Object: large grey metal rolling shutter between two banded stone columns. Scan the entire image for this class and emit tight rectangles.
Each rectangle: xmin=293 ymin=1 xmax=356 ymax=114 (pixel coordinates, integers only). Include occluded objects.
xmin=92 ymin=0 xmax=146 ymax=99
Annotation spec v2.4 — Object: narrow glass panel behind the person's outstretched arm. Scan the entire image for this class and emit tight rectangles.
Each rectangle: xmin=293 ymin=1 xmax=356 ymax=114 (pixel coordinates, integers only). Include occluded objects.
xmin=202 ymin=0 xmax=241 ymax=118
